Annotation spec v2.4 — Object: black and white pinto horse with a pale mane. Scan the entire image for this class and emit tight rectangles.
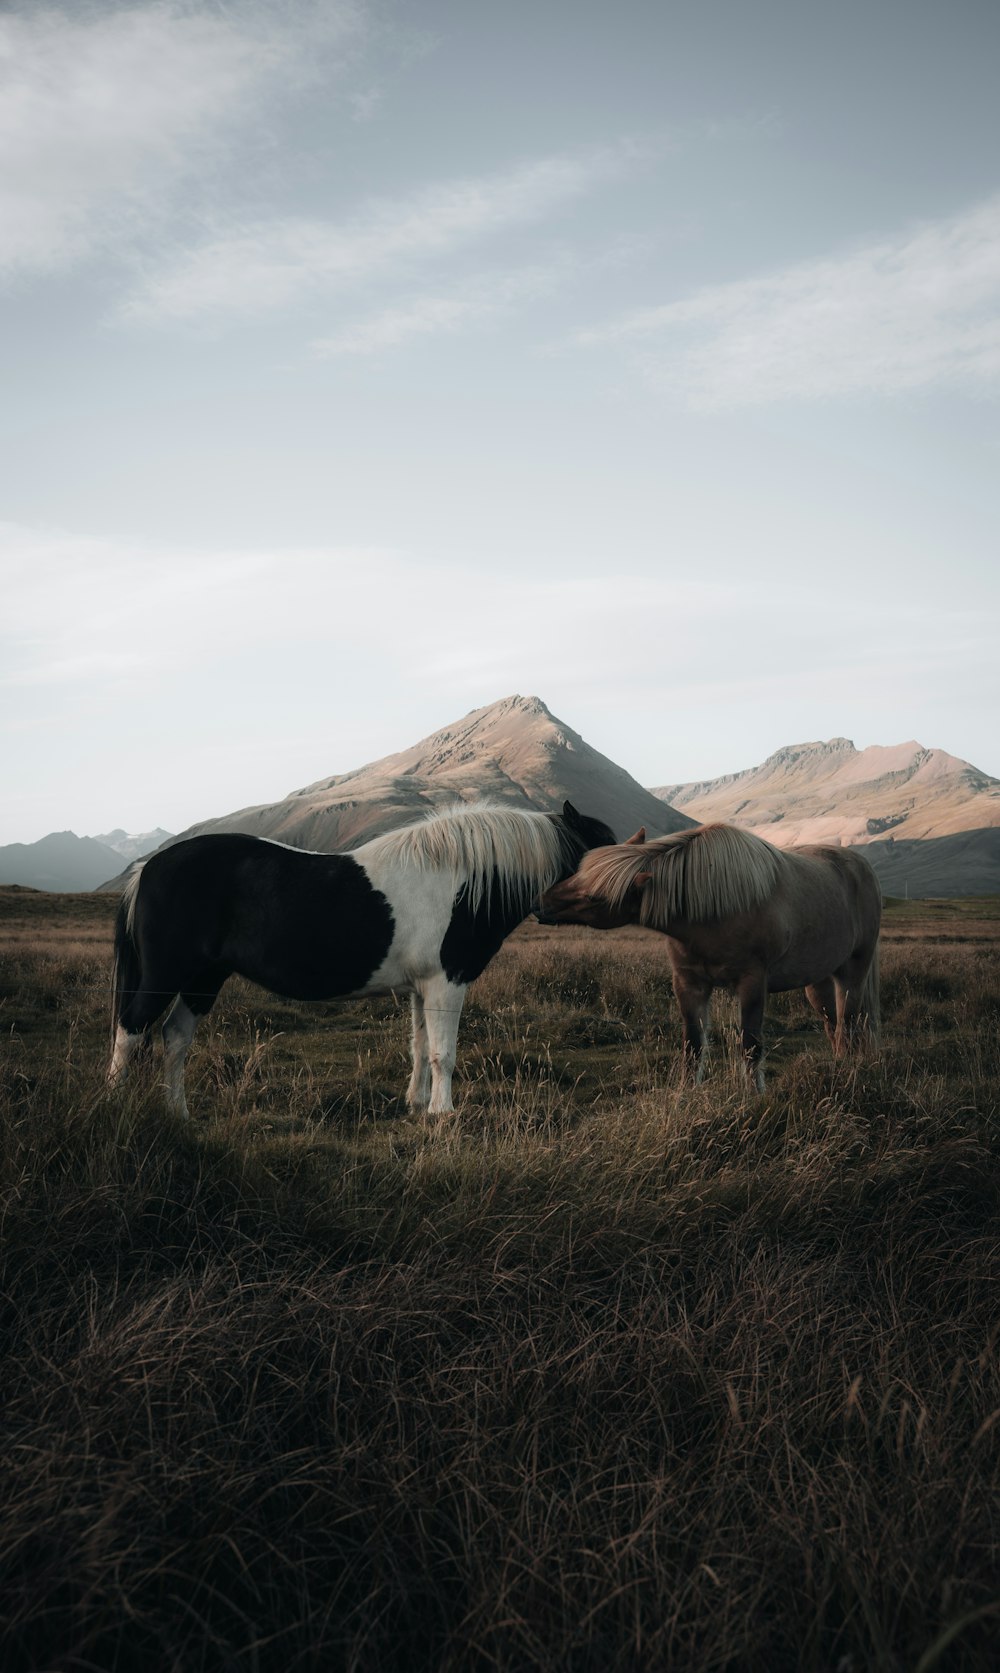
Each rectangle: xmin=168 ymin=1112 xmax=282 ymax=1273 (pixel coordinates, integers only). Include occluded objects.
xmin=109 ymin=801 xmax=614 ymax=1116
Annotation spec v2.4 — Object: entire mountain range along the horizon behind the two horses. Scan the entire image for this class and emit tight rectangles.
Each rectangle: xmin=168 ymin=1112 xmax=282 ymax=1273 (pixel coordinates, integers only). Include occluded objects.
xmin=7 ymin=696 xmax=1000 ymax=897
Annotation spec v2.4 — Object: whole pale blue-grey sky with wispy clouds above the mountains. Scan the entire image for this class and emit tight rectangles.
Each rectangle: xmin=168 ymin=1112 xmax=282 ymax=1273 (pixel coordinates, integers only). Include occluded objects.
xmin=0 ymin=0 xmax=1000 ymax=843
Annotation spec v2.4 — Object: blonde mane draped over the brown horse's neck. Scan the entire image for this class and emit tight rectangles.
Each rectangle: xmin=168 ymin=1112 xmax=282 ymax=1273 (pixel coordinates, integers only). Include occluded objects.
xmin=584 ymin=825 xmax=783 ymax=929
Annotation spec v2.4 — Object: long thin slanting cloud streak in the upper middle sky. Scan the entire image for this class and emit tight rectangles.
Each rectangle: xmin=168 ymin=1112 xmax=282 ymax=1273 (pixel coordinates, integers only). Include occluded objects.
xmin=129 ymin=144 xmax=637 ymax=320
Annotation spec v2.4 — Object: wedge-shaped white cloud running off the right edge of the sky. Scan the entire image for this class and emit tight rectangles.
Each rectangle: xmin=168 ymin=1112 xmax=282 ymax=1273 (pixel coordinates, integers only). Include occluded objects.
xmin=582 ymin=197 xmax=1000 ymax=410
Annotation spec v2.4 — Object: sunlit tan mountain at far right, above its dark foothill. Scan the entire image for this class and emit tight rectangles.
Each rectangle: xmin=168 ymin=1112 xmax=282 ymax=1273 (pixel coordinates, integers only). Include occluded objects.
xmin=652 ymin=738 xmax=1000 ymax=847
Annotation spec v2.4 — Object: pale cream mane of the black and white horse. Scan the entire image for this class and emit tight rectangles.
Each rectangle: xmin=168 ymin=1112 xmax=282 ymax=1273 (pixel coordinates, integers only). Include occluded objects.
xmin=355 ymin=801 xmax=572 ymax=912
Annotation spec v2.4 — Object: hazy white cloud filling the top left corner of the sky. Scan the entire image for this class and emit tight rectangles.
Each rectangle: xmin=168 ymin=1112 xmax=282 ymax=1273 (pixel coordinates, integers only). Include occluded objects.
xmin=0 ymin=0 xmax=360 ymax=276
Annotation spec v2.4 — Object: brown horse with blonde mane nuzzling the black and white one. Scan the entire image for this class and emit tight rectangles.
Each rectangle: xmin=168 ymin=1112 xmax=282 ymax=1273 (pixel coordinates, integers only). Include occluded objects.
xmin=538 ymin=825 xmax=881 ymax=1091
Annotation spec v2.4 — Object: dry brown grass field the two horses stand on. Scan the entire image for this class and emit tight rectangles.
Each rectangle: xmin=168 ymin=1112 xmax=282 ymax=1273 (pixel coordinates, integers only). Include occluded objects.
xmin=0 ymin=890 xmax=1000 ymax=1673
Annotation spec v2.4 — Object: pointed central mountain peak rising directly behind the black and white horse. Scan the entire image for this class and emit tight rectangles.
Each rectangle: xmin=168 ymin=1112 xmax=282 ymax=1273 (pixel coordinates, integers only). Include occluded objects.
xmin=170 ymin=696 xmax=696 ymax=852
